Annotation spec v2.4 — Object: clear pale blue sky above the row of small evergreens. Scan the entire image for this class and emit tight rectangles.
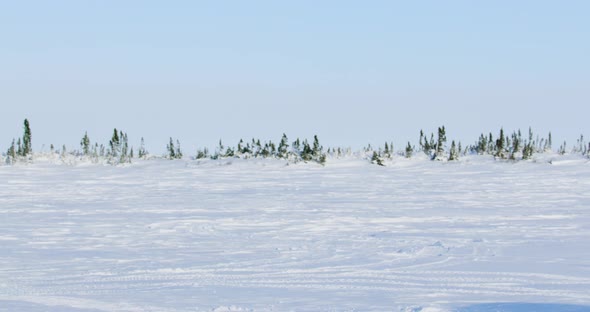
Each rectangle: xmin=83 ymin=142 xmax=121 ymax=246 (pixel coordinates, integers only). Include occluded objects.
xmin=0 ymin=0 xmax=590 ymax=154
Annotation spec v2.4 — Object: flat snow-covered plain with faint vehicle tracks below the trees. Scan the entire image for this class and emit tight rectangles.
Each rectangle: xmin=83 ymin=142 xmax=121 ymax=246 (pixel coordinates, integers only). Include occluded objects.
xmin=0 ymin=156 xmax=590 ymax=312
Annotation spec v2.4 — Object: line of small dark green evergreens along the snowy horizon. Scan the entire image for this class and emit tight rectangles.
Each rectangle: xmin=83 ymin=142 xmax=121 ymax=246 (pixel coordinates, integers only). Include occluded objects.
xmin=2 ymin=119 xmax=590 ymax=166
